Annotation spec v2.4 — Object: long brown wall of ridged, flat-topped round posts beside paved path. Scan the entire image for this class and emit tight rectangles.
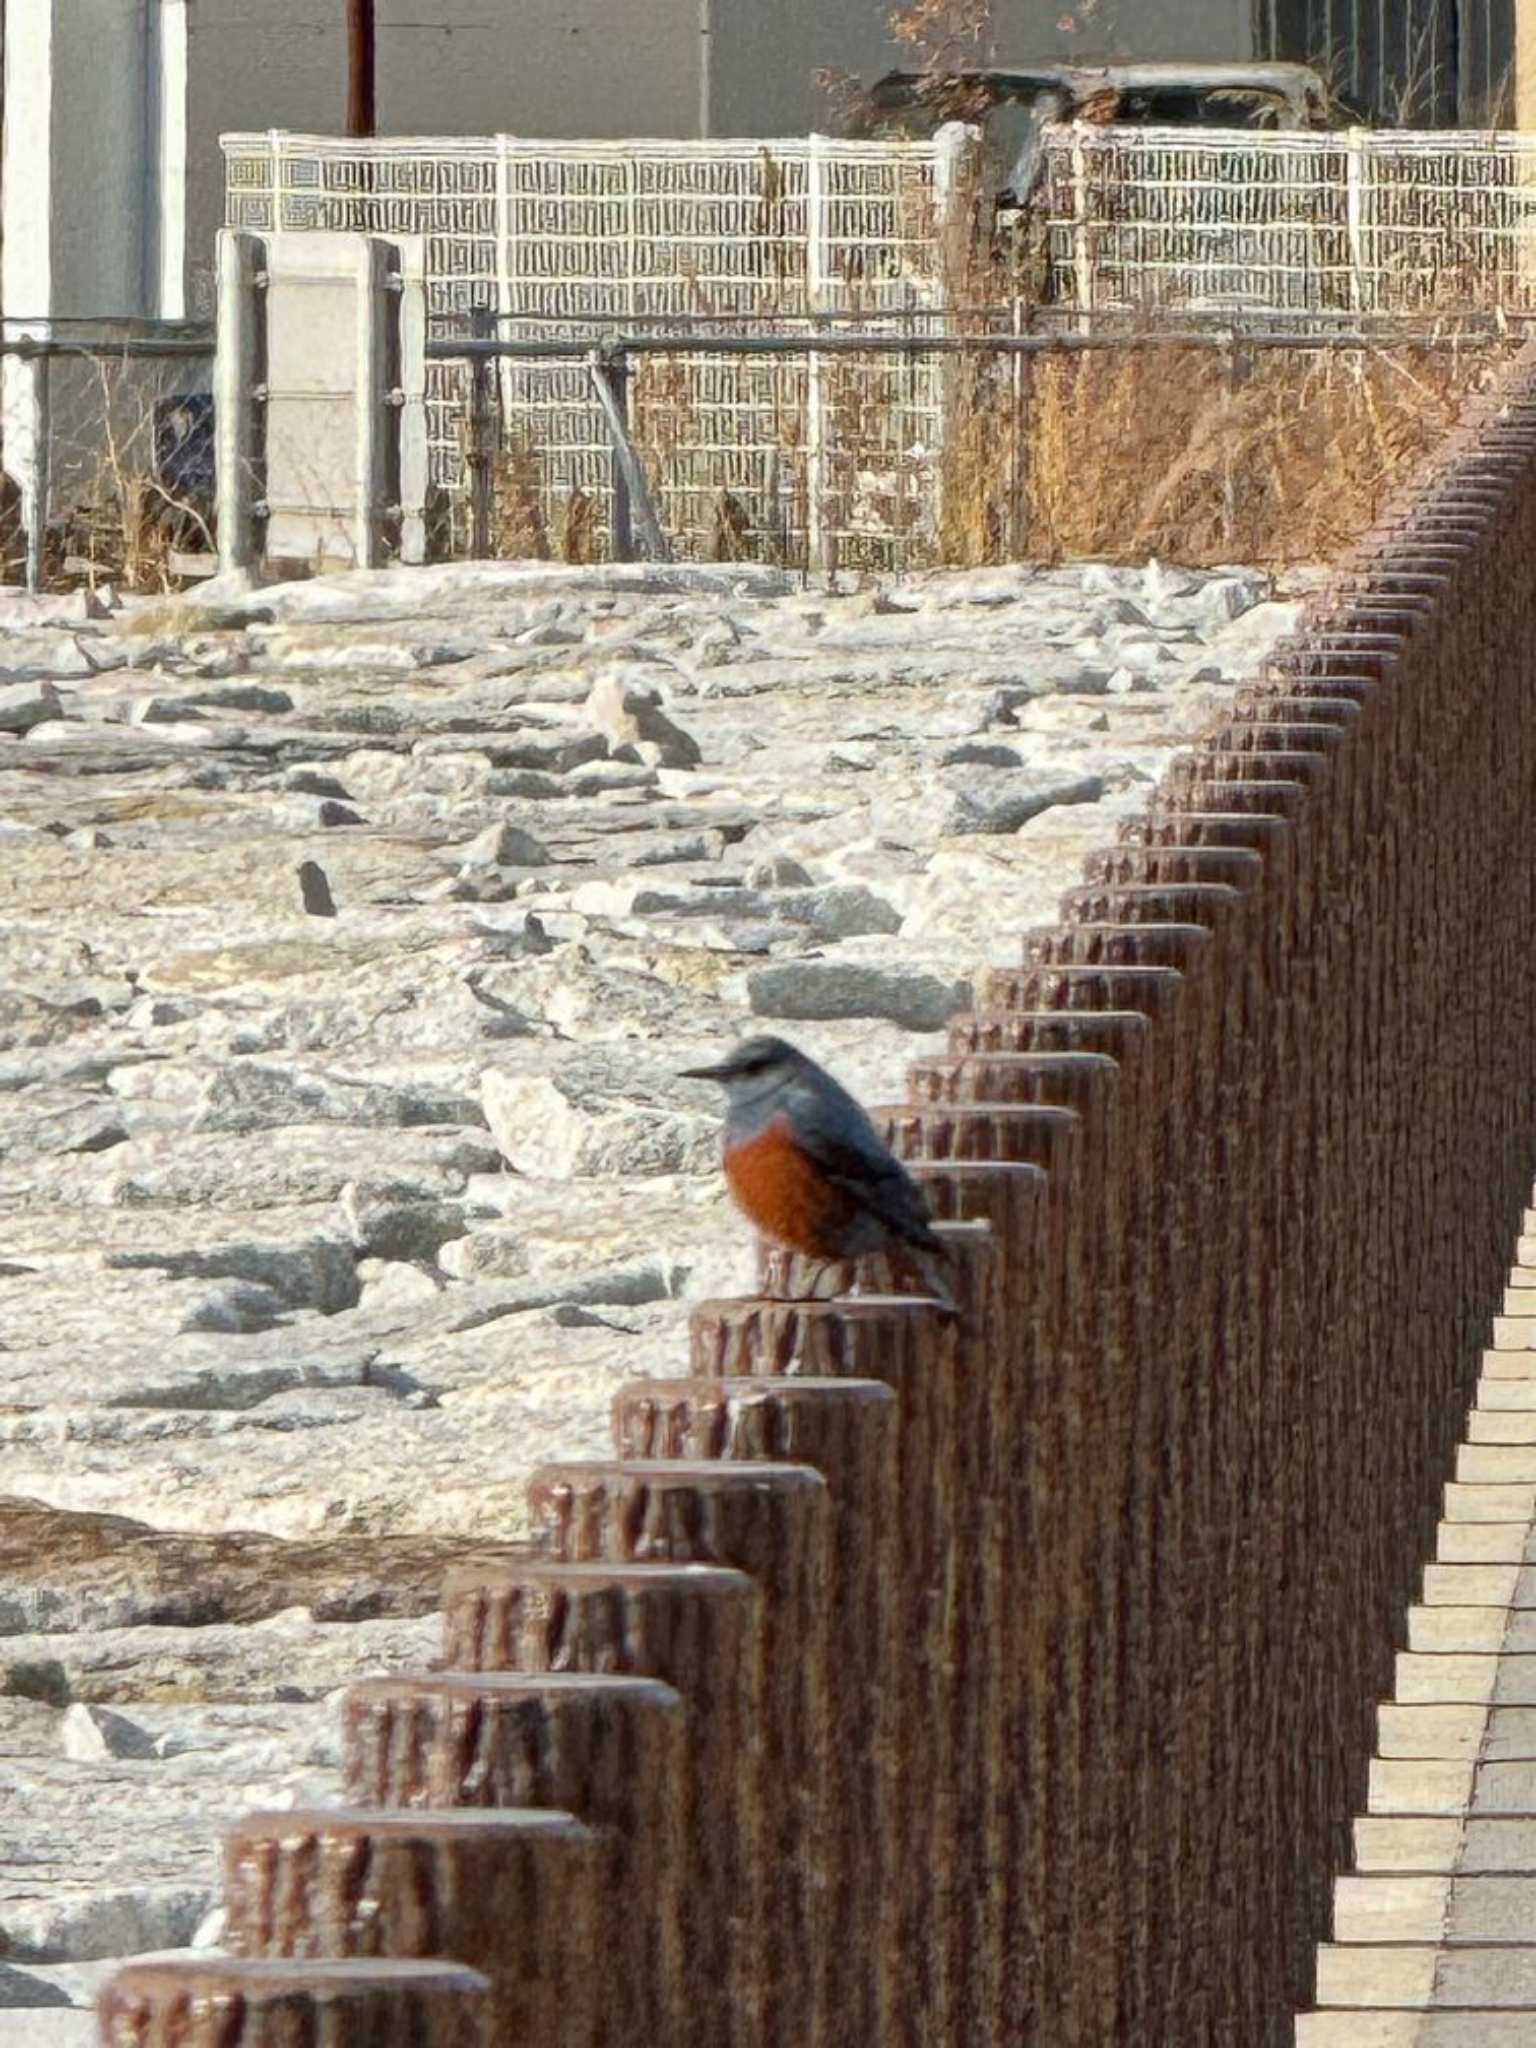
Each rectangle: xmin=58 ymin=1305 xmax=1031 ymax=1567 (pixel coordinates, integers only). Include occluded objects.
xmin=106 ymin=348 xmax=1536 ymax=2048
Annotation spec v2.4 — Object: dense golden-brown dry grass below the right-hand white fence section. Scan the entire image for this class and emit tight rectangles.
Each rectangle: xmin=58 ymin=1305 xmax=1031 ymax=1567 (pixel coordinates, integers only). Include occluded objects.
xmin=974 ymin=344 xmax=1499 ymax=563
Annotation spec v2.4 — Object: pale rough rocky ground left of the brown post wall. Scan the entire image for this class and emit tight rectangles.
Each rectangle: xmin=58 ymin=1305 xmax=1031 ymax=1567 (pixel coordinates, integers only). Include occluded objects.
xmin=0 ymin=548 xmax=1311 ymax=2048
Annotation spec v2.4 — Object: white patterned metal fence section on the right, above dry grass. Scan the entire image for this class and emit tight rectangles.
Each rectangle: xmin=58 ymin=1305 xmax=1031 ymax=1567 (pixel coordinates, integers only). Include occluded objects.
xmin=1044 ymin=125 xmax=1536 ymax=330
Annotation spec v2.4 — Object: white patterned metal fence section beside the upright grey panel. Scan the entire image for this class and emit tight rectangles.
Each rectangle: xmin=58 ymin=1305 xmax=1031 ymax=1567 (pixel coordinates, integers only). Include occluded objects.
xmin=223 ymin=131 xmax=969 ymax=565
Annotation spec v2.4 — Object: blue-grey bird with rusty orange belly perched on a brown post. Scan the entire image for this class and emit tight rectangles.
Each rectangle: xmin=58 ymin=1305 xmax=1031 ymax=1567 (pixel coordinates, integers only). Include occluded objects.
xmin=682 ymin=1038 xmax=952 ymax=1305
